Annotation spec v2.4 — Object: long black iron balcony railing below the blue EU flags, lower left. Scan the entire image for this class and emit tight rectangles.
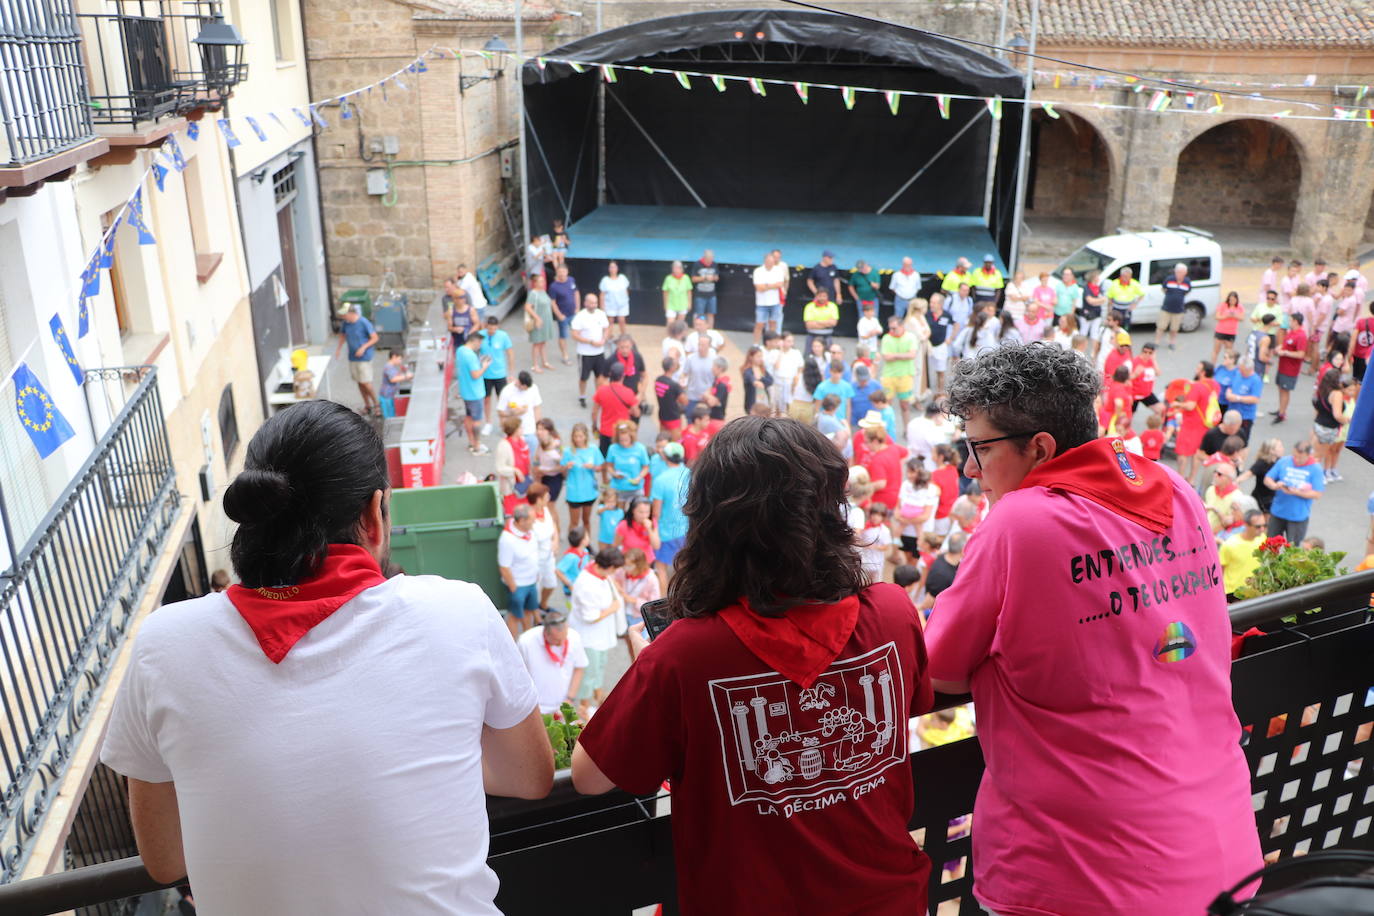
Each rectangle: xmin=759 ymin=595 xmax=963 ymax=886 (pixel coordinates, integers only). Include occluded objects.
xmin=0 ymin=367 xmax=180 ymax=889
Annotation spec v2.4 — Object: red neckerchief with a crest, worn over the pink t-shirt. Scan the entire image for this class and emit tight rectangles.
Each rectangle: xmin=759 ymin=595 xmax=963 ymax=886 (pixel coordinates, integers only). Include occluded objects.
xmin=1017 ymin=438 xmax=1173 ymax=534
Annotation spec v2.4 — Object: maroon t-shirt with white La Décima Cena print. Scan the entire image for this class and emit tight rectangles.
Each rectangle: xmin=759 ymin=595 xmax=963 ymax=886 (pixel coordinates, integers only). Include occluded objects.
xmin=578 ymin=584 xmax=933 ymax=916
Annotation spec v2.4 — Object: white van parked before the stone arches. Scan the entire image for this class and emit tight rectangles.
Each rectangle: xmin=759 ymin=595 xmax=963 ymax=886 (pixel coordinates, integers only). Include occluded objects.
xmin=1055 ymin=227 xmax=1221 ymax=331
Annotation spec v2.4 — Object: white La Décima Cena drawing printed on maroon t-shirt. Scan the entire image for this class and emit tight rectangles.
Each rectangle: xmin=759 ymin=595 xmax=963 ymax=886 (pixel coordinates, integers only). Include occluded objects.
xmin=706 ymin=643 xmax=907 ymax=817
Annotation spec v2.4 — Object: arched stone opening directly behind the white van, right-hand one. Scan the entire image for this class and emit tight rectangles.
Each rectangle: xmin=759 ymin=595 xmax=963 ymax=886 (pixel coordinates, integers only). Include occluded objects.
xmin=1169 ymin=118 xmax=1303 ymax=231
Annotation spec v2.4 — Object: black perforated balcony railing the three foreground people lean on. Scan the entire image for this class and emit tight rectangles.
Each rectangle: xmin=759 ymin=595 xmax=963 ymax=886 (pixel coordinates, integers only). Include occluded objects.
xmin=0 ymin=571 xmax=1374 ymax=916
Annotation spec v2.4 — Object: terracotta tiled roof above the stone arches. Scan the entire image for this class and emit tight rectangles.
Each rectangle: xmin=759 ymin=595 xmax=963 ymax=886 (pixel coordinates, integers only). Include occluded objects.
xmin=1009 ymin=0 xmax=1374 ymax=48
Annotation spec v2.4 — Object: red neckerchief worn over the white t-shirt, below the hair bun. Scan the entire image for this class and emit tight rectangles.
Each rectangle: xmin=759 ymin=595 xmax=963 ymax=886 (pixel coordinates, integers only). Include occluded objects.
xmin=224 ymin=544 xmax=386 ymax=663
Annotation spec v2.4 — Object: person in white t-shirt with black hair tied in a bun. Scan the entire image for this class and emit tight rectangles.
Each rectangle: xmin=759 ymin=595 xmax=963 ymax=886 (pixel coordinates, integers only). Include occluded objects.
xmin=100 ymin=400 xmax=554 ymax=916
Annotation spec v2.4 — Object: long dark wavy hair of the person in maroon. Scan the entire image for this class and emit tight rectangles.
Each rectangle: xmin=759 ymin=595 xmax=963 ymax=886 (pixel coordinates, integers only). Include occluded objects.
xmin=668 ymin=416 xmax=867 ymax=617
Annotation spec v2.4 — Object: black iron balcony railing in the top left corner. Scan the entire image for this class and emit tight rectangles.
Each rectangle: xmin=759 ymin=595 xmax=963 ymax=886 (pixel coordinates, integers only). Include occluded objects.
xmin=0 ymin=0 xmax=95 ymax=168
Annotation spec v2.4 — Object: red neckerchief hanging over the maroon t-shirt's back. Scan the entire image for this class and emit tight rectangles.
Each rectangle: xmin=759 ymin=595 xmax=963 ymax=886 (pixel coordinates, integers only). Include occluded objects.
xmin=720 ymin=595 xmax=859 ymax=687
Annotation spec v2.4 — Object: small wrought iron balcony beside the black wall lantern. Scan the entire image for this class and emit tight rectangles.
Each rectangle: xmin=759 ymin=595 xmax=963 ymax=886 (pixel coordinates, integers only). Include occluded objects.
xmin=80 ymin=0 xmax=247 ymax=126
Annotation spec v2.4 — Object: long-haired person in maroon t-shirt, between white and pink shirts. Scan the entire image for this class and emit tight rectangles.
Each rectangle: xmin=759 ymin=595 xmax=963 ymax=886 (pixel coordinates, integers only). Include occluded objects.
xmin=573 ymin=416 xmax=933 ymax=916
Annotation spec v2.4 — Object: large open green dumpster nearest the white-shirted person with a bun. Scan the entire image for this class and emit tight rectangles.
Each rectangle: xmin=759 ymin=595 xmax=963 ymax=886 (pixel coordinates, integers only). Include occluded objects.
xmin=392 ymin=483 xmax=510 ymax=607
